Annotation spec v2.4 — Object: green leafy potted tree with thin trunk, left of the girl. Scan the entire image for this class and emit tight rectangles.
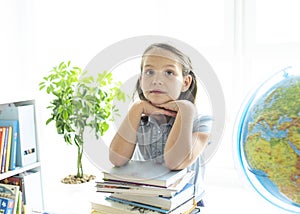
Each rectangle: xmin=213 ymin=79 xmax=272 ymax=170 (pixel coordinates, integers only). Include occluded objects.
xmin=39 ymin=61 xmax=125 ymax=183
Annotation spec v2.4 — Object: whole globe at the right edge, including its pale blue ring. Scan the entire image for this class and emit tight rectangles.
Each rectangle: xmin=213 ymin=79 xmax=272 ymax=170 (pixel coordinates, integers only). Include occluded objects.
xmin=234 ymin=68 xmax=300 ymax=213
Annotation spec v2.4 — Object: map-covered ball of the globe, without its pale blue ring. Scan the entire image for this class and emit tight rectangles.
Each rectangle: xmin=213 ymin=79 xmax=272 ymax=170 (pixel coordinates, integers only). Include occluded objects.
xmin=242 ymin=75 xmax=300 ymax=207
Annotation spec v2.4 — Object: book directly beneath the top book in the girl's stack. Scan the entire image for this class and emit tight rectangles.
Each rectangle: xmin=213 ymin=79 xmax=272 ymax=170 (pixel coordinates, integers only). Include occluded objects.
xmin=96 ymin=181 xmax=176 ymax=197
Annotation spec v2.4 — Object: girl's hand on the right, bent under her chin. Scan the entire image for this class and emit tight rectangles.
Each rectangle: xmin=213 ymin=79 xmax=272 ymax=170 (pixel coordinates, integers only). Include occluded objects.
xmin=157 ymin=100 xmax=196 ymax=115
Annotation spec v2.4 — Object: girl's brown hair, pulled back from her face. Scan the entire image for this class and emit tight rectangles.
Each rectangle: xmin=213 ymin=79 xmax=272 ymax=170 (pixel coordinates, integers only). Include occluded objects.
xmin=135 ymin=43 xmax=197 ymax=103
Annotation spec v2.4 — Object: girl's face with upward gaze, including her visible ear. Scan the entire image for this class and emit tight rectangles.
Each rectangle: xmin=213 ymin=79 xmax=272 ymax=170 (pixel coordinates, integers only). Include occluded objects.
xmin=140 ymin=48 xmax=192 ymax=105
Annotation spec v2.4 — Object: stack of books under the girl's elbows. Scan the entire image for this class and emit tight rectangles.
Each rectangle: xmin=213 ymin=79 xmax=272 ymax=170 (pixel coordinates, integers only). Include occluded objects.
xmin=91 ymin=161 xmax=196 ymax=214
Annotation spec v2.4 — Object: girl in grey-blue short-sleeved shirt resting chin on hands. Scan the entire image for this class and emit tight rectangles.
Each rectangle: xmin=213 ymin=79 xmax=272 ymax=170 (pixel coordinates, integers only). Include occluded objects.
xmin=109 ymin=43 xmax=211 ymax=206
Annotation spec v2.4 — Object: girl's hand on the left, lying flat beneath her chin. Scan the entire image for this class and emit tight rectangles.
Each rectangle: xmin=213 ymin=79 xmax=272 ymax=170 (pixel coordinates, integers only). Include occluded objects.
xmin=133 ymin=100 xmax=177 ymax=117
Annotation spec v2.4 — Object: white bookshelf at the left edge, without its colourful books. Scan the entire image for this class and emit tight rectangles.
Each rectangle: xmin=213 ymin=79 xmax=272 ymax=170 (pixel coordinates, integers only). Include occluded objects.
xmin=0 ymin=99 xmax=44 ymax=213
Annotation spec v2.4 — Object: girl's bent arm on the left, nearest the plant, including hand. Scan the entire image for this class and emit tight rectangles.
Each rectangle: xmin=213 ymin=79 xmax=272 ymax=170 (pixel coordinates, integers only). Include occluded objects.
xmin=109 ymin=101 xmax=175 ymax=166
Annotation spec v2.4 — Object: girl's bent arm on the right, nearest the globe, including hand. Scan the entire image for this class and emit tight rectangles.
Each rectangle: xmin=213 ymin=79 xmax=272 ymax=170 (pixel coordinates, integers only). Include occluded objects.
xmin=158 ymin=100 xmax=209 ymax=170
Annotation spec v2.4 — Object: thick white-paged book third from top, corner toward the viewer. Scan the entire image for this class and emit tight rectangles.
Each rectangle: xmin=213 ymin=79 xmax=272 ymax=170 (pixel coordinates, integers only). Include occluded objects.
xmin=110 ymin=183 xmax=194 ymax=210
